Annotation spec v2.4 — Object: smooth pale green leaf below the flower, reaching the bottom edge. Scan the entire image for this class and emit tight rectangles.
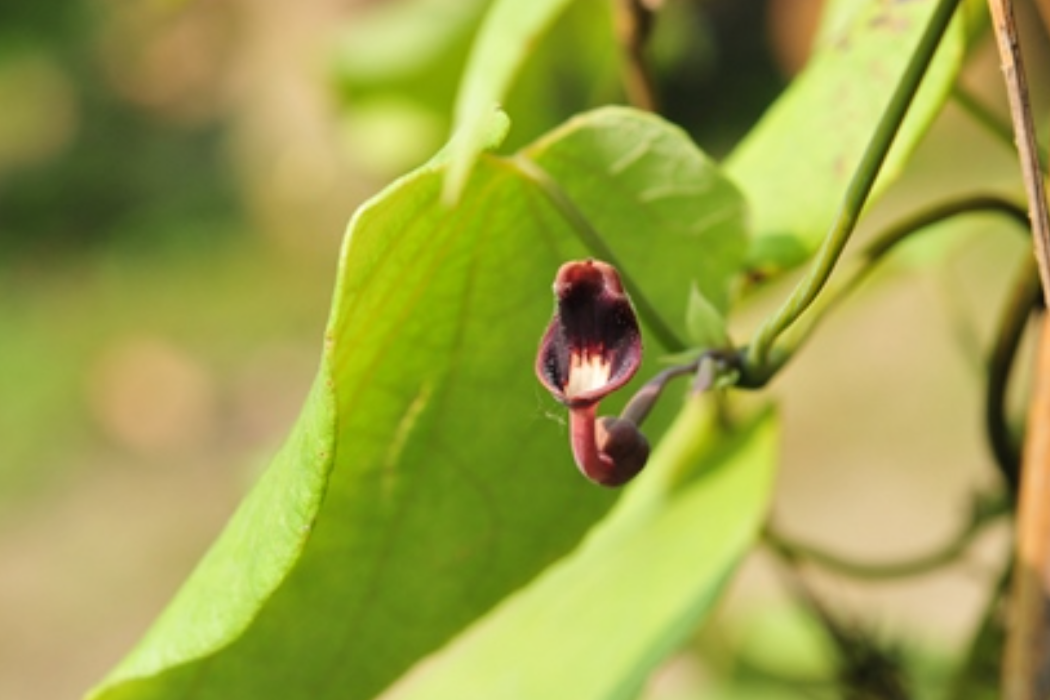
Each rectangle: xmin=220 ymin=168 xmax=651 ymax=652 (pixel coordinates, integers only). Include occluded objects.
xmin=384 ymin=397 xmax=776 ymax=700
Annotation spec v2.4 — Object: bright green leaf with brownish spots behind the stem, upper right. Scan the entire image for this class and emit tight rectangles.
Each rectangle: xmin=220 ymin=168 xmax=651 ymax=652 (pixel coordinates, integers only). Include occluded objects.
xmin=727 ymin=0 xmax=968 ymax=268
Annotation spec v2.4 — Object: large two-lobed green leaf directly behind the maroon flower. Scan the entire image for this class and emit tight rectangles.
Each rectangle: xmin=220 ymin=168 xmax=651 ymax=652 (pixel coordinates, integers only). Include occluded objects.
xmin=93 ymin=109 xmax=746 ymax=700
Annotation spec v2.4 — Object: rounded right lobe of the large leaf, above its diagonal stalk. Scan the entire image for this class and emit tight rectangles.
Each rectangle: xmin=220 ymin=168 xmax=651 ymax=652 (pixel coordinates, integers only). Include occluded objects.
xmin=525 ymin=107 xmax=746 ymax=321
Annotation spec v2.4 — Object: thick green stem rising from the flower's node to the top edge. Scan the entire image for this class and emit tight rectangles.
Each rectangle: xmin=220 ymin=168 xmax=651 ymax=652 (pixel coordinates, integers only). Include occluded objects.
xmin=742 ymin=0 xmax=960 ymax=386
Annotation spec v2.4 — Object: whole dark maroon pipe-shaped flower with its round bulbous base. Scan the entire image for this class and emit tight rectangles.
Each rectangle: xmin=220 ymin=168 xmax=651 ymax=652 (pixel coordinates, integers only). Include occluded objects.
xmin=536 ymin=259 xmax=649 ymax=486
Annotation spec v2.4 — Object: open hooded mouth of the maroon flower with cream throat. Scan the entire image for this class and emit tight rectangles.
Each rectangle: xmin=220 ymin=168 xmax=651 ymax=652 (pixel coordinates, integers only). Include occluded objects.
xmin=536 ymin=259 xmax=642 ymax=408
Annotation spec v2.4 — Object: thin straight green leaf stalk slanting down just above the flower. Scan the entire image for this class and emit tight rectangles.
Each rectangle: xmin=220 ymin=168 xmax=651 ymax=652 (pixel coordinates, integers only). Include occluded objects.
xmin=506 ymin=154 xmax=686 ymax=353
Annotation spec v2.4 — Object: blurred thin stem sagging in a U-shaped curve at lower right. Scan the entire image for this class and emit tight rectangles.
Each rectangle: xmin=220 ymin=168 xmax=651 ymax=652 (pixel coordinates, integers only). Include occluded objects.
xmin=762 ymin=496 xmax=1010 ymax=581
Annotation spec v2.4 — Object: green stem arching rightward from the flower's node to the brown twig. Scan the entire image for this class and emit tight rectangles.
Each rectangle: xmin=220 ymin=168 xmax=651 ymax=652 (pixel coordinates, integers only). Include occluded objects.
xmin=743 ymin=195 xmax=1028 ymax=387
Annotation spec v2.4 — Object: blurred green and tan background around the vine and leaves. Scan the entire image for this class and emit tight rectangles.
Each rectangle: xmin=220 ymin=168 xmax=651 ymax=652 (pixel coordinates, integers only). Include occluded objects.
xmin=0 ymin=0 xmax=1048 ymax=700
